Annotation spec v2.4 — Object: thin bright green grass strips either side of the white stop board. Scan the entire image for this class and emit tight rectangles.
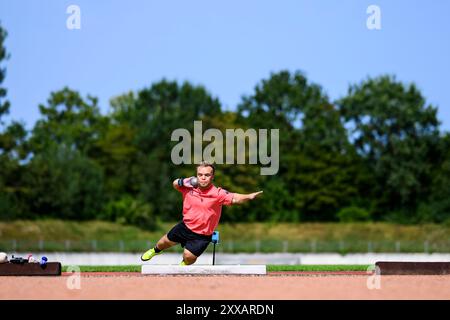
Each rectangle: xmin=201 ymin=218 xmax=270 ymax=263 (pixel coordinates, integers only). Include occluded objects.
xmin=62 ymin=264 xmax=369 ymax=272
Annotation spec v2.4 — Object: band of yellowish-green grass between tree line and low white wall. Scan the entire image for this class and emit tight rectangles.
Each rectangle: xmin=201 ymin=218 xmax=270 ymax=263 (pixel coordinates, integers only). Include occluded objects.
xmin=0 ymin=220 xmax=450 ymax=254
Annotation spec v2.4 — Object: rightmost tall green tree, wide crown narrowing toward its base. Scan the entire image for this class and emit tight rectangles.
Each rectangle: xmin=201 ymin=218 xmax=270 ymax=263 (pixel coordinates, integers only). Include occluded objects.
xmin=338 ymin=76 xmax=439 ymax=221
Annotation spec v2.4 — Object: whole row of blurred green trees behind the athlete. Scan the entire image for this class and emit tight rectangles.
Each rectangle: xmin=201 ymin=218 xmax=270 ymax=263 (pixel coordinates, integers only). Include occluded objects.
xmin=0 ymin=26 xmax=450 ymax=228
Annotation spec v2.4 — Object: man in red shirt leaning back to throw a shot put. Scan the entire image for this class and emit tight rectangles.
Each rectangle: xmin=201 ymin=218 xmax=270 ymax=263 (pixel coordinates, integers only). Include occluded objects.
xmin=141 ymin=162 xmax=262 ymax=265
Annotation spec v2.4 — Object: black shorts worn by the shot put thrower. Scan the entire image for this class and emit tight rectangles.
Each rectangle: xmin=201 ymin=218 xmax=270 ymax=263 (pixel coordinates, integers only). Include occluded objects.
xmin=167 ymin=221 xmax=212 ymax=257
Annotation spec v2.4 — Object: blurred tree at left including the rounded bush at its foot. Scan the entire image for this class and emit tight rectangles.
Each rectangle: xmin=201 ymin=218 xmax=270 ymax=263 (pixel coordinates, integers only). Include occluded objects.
xmin=25 ymin=88 xmax=107 ymax=219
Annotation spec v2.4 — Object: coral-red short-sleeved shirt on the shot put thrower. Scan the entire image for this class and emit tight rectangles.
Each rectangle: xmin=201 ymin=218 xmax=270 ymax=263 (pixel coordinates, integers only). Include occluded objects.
xmin=178 ymin=185 xmax=234 ymax=235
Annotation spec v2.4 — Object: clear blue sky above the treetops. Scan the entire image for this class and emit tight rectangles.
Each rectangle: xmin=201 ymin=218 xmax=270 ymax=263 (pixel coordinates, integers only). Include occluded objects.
xmin=0 ymin=0 xmax=450 ymax=131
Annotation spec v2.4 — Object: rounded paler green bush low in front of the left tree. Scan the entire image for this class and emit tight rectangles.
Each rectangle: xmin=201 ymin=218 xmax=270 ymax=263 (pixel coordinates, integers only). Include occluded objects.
xmin=26 ymin=144 xmax=104 ymax=220
